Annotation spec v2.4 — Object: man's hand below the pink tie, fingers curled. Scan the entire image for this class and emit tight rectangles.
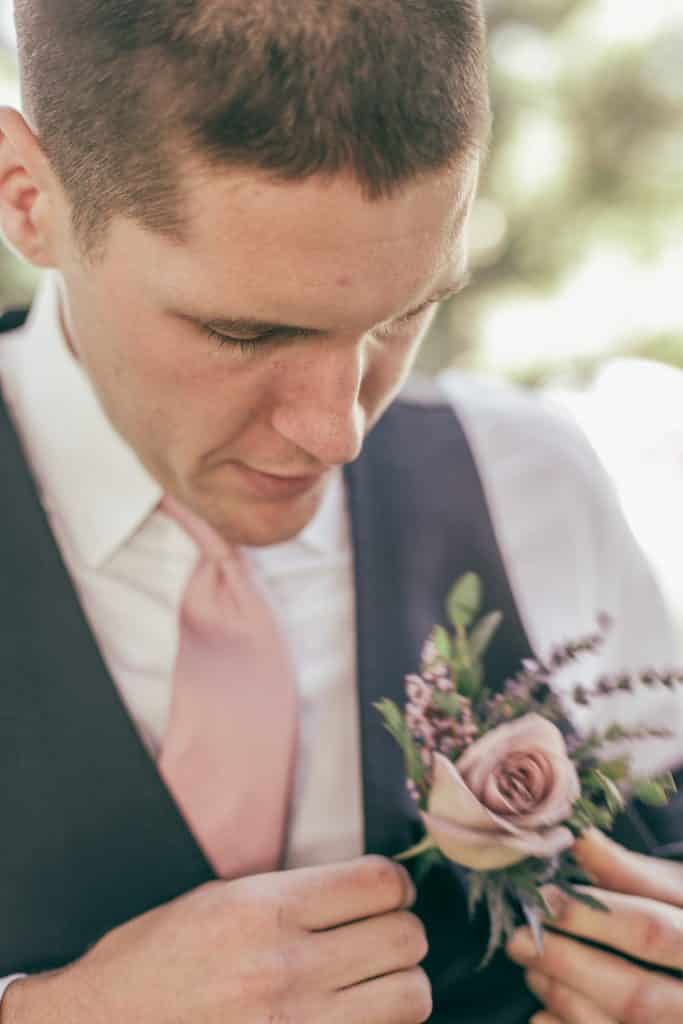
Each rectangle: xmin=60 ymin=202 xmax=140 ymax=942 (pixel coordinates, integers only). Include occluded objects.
xmin=0 ymin=857 xmax=431 ymax=1024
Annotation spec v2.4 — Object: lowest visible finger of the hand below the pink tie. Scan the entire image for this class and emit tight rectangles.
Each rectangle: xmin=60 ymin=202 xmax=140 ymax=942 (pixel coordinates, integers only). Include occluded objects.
xmin=326 ymin=968 xmax=432 ymax=1024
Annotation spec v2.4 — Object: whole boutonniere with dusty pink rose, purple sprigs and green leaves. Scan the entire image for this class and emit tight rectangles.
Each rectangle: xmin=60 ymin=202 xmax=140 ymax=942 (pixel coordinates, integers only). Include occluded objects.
xmin=375 ymin=573 xmax=683 ymax=966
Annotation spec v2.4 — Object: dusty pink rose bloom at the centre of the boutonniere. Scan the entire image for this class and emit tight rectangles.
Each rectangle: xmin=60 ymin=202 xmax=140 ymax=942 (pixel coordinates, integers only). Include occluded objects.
xmin=422 ymin=715 xmax=581 ymax=871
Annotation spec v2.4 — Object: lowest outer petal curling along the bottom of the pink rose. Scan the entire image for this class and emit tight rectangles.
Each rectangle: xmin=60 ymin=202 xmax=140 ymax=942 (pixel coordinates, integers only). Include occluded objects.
xmin=422 ymin=812 xmax=573 ymax=871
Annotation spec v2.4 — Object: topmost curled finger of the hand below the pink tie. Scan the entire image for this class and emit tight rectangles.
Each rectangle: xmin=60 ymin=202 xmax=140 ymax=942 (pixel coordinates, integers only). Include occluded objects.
xmin=284 ymin=856 xmax=415 ymax=931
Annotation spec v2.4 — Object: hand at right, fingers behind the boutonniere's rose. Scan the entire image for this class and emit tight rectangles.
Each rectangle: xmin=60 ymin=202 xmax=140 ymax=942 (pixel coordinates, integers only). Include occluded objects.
xmin=508 ymin=831 xmax=683 ymax=1024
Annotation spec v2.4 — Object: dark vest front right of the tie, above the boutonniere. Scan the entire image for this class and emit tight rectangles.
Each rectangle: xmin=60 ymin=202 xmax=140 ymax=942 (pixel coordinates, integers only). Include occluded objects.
xmin=346 ymin=387 xmax=530 ymax=855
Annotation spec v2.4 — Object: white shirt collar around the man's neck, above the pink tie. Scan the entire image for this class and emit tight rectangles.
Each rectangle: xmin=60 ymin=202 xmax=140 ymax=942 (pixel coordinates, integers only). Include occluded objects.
xmin=10 ymin=271 xmax=347 ymax=569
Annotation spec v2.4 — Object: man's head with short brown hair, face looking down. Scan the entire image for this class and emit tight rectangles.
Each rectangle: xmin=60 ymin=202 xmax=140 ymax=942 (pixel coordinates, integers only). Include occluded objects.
xmin=0 ymin=0 xmax=487 ymax=544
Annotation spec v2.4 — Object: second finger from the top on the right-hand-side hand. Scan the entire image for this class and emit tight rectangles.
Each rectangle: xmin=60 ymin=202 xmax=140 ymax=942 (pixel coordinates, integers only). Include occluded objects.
xmin=544 ymin=886 xmax=683 ymax=970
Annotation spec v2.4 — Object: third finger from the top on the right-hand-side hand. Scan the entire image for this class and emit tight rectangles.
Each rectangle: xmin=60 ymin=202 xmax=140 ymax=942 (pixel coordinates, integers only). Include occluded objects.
xmin=507 ymin=928 xmax=683 ymax=1024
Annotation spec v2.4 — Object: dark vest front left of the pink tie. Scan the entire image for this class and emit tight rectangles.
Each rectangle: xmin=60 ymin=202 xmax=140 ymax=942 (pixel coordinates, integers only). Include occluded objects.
xmin=0 ymin=385 xmax=213 ymax=975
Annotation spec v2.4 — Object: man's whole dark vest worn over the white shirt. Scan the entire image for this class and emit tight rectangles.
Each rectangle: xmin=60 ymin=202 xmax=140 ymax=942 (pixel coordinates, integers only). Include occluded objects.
xmin=0 ymin=314 xmax=681 ymax=1024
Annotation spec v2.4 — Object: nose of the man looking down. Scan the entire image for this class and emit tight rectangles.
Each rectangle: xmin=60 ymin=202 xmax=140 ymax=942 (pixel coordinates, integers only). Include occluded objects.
xmin=271 ymin=339 xmax=367 ymax=466
